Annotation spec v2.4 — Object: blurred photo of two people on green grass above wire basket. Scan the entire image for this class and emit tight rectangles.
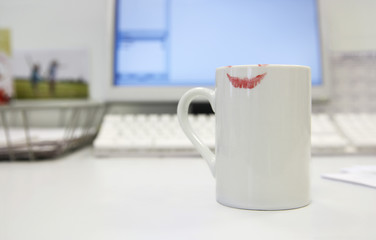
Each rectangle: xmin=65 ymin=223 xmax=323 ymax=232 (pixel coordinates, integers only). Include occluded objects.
xmin=12 ymin=50 xmax=88 ymax=99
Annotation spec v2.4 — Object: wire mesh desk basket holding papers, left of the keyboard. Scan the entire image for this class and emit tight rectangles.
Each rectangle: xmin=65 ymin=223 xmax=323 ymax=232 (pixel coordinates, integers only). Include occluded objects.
xmin=0 ymin=103 xmax=105 ymax=161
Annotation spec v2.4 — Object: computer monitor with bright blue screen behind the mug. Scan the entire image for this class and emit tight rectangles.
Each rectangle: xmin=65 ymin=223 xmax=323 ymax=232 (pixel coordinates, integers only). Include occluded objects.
xmin=106 ymin=0 xmax=328 ymax=102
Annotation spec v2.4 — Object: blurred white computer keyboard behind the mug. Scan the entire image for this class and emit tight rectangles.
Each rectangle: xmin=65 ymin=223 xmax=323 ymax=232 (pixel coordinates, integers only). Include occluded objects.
xmin=94 ymin=114 xmax=376 ymax=157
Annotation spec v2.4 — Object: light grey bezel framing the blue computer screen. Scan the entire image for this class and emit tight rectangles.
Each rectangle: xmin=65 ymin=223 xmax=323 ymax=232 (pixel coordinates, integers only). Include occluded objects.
xmin=104 ymin=0 xmax=331 ymax=103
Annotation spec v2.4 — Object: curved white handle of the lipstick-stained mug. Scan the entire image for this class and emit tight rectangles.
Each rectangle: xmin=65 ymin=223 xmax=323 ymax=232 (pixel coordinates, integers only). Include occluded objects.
xmin=178 ymin=87 xmax=215 ymax=177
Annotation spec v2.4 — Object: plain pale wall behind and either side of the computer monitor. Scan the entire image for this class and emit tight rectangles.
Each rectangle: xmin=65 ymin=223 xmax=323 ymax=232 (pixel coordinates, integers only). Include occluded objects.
xmin=0 ymin=0 xmax=376 ymax=100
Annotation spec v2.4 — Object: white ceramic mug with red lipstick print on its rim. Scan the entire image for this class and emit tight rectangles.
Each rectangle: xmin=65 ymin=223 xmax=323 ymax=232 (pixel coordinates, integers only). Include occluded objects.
xmin=178 ymin=64 xmax=311 ymax=210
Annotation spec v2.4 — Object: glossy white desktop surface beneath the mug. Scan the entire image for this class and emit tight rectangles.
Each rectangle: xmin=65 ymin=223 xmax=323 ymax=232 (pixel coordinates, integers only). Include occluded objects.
xmin=0 ymin=148 xmax=376 ymax=240
